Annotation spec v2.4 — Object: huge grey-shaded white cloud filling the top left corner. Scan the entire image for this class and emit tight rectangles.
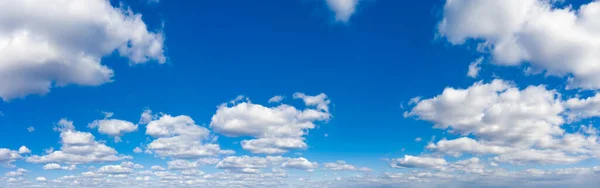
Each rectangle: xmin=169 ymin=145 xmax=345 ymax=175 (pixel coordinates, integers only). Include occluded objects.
xmin=0 ymin=0 xmax=166 ymax=100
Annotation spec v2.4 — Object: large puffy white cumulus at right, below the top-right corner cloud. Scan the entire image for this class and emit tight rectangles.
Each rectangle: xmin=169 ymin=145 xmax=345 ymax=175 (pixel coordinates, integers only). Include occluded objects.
xmin=407 ymin=80 xmax=564 ymax=148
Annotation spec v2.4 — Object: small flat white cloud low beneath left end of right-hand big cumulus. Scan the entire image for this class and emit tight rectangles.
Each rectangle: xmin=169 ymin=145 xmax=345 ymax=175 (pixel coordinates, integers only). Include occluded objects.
xmin=390 ymin=155 xmax=448 ymax=169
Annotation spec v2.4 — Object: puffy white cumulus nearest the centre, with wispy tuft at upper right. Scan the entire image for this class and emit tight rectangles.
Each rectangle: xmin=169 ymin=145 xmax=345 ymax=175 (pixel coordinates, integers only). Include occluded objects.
xmin=210 ymin=93 xmax=331 ymax=154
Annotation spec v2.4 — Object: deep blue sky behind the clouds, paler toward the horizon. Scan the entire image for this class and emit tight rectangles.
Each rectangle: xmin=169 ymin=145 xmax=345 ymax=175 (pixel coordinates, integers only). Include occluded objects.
xmin=0 ymin=0 xmax=600 ymax=187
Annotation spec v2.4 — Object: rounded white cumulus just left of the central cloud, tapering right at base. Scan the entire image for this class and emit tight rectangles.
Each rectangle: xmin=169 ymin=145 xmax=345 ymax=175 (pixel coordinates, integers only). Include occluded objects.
xmin=146 ymin=114 xmax=233 ymax=159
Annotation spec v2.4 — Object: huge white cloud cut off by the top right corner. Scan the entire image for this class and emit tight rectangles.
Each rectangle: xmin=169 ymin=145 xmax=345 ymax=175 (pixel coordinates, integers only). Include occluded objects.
xmin=439 ymin=0 xmax=600 ymax=89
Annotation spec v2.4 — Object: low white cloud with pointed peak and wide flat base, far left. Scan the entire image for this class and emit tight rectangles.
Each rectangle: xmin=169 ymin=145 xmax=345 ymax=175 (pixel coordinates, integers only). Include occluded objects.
xmin=27 ymin=119 xmax=127 ymax=164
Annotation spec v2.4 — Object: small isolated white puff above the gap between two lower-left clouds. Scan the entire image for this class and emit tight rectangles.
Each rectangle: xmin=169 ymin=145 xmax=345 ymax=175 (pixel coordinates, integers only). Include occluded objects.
xmin=88 ymin=119 xmax=138 ymax=142
